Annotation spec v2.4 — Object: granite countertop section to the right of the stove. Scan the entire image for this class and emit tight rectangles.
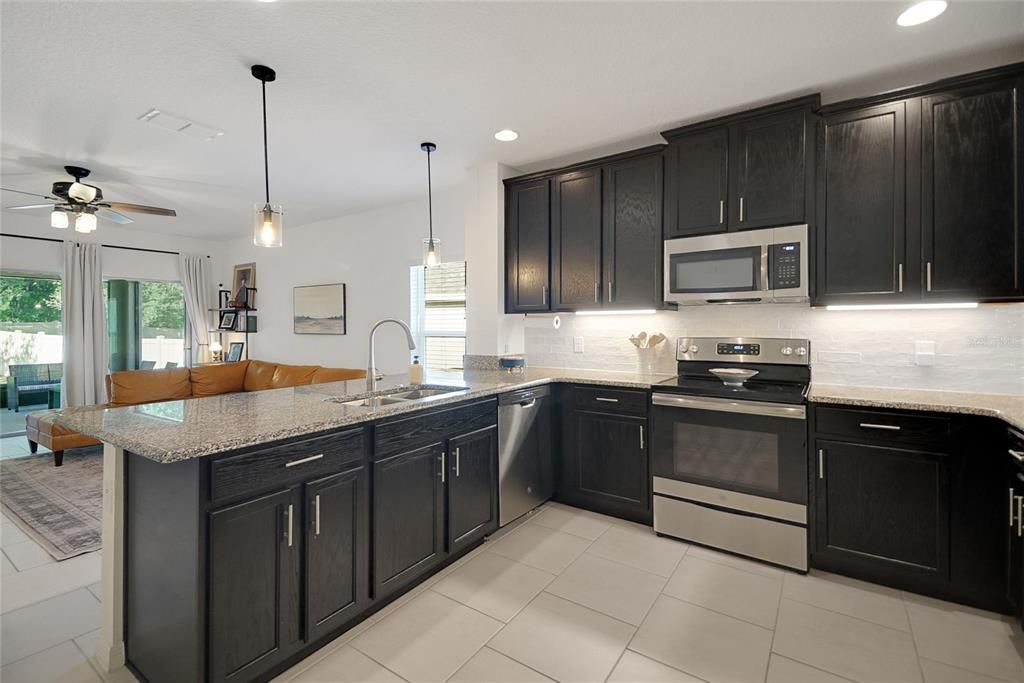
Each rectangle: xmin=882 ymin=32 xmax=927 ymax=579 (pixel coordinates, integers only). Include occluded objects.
xmin=807 ymin=383 xmax=1024 ymax=429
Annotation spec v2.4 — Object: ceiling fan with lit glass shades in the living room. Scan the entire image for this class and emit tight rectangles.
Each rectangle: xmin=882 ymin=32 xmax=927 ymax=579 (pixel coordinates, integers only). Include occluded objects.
xmin=0 ymin=166 xmax=177 ymax=232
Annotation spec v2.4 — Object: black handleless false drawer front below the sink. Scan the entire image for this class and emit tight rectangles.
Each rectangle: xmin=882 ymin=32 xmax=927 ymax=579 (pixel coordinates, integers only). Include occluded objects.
xmin=374 ymin=399 xmax=498 ymax=460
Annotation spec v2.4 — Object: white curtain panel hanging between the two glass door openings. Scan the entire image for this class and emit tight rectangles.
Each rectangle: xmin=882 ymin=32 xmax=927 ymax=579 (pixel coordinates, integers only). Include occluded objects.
xmin=60 ymin=242 xmax=110 ymax=405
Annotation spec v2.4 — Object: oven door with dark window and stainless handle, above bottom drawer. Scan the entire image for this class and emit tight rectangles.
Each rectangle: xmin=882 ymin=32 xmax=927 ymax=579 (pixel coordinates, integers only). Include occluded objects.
xmin=651 ymin=393 xmax=808 ymax=505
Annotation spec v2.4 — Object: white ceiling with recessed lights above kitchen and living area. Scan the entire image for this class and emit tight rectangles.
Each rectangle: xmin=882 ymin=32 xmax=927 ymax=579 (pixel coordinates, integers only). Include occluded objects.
xmin=0 ymin=0 xmax=1024 ymax=239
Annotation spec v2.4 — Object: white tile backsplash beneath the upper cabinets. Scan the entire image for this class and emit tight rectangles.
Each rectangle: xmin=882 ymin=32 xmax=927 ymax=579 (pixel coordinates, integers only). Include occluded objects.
xmin=524 ymin=303 xmax=1024 ymax=394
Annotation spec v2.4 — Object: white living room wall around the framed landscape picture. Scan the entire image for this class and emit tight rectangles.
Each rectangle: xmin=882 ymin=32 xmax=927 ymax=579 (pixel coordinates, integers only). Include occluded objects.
xmin=217 ymin=190 xmax=464 ymax=373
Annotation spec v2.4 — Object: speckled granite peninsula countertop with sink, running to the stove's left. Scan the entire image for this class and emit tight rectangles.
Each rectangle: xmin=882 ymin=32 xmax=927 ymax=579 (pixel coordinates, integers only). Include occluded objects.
xmin=56 ymin=368 xmax=669 ymax=463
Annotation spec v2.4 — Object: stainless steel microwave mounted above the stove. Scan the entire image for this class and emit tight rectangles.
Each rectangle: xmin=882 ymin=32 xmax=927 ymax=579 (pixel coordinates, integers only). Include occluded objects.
xmin=665 ymin=225 xmax=810 ymax=305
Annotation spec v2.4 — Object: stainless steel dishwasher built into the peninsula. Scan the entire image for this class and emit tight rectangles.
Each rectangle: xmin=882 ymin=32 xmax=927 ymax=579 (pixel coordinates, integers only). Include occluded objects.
xmin=498 ymin=386 xmax=554 ymax=526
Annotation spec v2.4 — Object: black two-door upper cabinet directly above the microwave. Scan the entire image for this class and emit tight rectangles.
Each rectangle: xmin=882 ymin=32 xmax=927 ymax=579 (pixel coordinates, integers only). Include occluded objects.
xmin=663 ymin=95 xmax=819 ymax=238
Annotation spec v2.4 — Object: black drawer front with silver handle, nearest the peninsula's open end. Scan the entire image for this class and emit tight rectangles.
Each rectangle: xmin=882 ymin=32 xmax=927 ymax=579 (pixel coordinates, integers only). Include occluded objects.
xmin=210 ymin=429 xmax=369 ymax=503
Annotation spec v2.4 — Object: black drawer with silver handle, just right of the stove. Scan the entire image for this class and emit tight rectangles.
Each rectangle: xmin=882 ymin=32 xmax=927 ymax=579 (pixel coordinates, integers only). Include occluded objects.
xmin=815 ymin=408 xmax=952 ymax=441
